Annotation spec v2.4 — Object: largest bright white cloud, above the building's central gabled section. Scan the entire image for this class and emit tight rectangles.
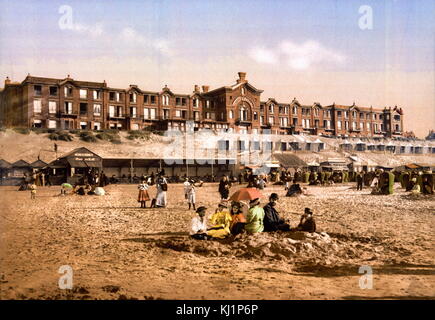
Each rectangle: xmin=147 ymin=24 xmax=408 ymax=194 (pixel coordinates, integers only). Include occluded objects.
xmin=249 ymin=40 xmax=346 ymax=70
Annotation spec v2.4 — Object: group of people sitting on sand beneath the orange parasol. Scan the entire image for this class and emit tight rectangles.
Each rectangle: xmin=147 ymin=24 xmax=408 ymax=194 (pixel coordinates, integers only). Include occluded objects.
xmin=190 ymin=193 xmax=316 ymax=240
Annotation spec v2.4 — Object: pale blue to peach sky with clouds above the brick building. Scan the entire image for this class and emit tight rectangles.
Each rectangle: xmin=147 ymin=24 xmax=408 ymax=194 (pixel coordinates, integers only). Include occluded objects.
xmin=0 ymin=0 xmax=435 ymax=137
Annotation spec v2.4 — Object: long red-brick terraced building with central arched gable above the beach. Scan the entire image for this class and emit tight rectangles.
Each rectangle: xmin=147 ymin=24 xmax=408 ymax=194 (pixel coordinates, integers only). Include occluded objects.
xmin=0 ymin=72 xmax=403 ymax=137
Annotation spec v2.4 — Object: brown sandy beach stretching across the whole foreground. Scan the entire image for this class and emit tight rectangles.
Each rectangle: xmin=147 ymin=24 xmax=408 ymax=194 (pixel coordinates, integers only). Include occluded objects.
xmin=0 ymin=184 xmax=435 ymax=299
